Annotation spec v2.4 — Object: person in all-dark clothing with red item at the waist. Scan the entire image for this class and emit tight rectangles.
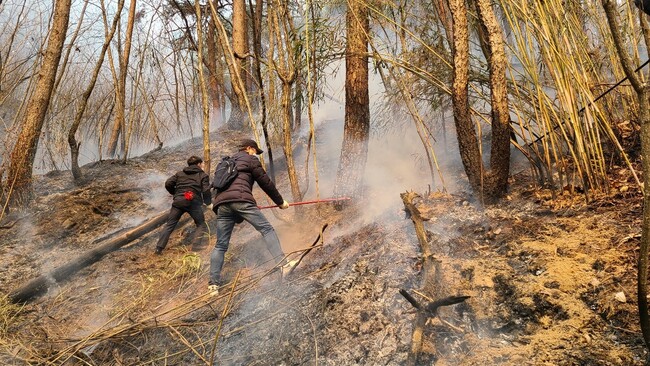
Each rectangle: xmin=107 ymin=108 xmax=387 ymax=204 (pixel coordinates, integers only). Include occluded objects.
xmin=155 ymin=156 xmax=212 ymax=254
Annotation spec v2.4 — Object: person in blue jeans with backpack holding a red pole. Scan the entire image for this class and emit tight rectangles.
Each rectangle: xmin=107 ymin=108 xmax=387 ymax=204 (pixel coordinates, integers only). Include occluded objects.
xmin=208 ymin=139 xmax=289 ymax=293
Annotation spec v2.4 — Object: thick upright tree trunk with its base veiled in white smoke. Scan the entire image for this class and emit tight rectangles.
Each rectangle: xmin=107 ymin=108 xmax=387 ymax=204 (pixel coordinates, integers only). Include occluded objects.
xmin=334 ymin=0 xmax=370 ymax=209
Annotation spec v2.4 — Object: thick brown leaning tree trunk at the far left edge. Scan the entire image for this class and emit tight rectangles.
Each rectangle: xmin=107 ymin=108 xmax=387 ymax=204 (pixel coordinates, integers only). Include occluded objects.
xmin=5 ymin=0 xmax=71 ymax=203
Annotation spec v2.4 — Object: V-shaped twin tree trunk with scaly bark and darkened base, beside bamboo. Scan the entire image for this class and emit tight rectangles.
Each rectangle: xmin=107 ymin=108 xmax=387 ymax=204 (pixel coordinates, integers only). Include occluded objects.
xmin=449 ymin=0 xmax=510 ymax=203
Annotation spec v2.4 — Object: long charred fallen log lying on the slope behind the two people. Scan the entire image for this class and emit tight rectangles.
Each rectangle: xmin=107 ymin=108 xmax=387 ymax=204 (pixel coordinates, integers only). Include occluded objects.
xmin=9 ymin=211 xmax=167 ymax=303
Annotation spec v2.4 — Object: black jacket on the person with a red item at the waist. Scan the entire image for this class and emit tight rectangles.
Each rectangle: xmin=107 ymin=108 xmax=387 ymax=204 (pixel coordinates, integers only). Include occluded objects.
xmin=165 ymin=165 xmax=212 ymax=205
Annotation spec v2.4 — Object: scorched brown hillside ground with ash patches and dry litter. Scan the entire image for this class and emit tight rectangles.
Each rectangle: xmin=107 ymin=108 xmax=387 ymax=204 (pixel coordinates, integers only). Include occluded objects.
xmin=0 ymin=127 xmax=647 ymax=365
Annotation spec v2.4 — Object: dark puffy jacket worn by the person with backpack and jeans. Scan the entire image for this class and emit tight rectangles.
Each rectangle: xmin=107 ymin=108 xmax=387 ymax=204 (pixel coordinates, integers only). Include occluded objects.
xmin=212 ymin=151 xmax=284 ymax=207
